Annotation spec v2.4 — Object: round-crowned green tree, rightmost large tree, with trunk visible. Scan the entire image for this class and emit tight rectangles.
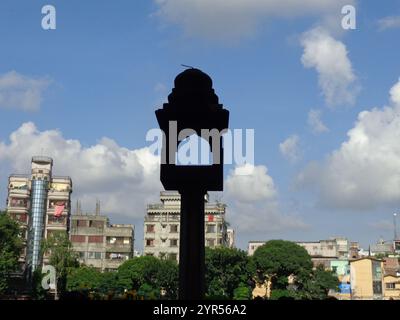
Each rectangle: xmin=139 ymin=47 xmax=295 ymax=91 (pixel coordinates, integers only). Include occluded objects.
xmin=253 ymin=240 xmax=312 ymax=290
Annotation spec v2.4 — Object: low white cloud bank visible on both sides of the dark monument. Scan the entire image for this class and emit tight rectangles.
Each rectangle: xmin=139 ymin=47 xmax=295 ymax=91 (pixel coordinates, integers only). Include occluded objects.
xmin=0 ymin=122 xmax=305 ymax=233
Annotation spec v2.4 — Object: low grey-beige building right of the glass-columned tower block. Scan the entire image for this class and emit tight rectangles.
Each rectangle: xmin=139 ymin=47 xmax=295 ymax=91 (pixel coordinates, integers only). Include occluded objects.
xmin=71 ymin=214 xmax=134 ymax=271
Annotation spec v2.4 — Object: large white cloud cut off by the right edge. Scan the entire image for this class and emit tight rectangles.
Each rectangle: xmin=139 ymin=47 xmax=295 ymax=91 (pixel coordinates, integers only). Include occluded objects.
xmin=297 ymin=81 xmax=400 ymax=210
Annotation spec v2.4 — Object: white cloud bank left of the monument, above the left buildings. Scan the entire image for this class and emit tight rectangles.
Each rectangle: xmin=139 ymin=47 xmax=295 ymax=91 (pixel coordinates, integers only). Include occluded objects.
xmin=0 ymin=122 xmax=162 ymax=218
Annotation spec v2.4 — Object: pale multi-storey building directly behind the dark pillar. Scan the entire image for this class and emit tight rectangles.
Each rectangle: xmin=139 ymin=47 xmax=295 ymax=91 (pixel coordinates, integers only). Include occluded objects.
xmin=144 ymin=191 xmax=228 ymax=261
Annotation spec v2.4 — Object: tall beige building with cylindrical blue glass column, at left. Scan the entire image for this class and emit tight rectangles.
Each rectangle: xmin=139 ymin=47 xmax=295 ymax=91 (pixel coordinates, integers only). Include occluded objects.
xmin=7 ymin=156 xmax=72 ymax=272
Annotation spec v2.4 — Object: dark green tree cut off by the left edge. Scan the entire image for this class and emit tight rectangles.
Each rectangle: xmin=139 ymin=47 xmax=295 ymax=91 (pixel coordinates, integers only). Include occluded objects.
xmin=0 ymin=212 xmax=22 ymax=294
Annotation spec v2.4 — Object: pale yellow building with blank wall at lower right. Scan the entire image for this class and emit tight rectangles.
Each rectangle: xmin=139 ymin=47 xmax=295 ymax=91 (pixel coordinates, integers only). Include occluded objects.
xmin=350 ymin=257 xmax=385 ymax=300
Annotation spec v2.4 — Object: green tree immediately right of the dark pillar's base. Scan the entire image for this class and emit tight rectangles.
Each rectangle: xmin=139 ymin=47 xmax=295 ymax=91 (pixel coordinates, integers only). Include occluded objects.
xmin=205 ymin=247 xmax=251 ymax=299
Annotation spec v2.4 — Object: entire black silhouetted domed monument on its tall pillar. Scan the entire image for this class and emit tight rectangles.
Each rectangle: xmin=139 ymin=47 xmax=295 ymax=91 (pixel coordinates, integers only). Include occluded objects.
xmin=156 ymin=68 xmax=229 ymax=300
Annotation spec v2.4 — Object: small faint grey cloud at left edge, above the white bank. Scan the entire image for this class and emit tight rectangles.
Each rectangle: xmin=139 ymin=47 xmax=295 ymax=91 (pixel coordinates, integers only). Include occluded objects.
xmin=0 ymin=71 xmax=51 ymax=111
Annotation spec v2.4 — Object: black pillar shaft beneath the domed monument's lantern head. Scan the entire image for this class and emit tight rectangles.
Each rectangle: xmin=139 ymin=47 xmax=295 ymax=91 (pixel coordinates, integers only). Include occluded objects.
xmin=179 ymin=189 xmax=205 ymax=300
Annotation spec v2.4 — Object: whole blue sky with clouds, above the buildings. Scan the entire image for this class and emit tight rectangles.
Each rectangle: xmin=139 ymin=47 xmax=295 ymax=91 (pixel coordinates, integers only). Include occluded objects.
xmin=0 ymin=0 xmax=400 ymax=250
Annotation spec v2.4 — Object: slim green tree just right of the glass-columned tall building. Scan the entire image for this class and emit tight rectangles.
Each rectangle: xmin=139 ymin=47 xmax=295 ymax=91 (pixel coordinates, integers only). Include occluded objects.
xmin=42 ymin=232 xmax=79 ymax=295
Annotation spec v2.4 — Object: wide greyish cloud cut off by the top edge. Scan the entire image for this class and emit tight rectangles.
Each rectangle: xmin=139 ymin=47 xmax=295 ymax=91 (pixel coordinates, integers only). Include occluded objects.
xmin=155 ymin=0 xmax=354 ymax=41
